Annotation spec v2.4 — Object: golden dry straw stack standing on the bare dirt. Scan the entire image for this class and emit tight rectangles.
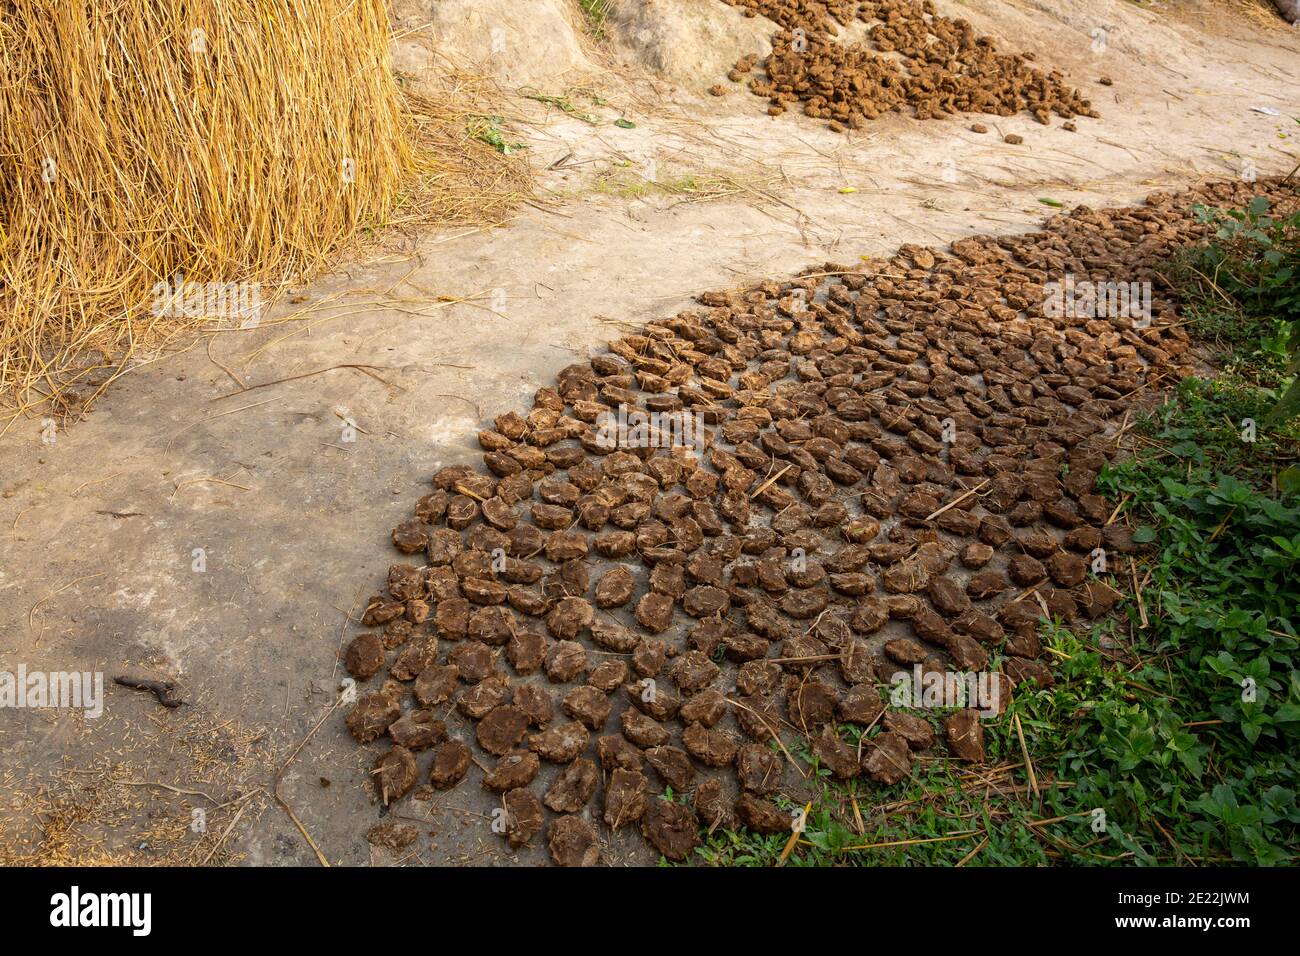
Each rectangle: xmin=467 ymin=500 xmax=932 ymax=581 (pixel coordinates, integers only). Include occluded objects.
xmin=0 ymin=0 xmax=517 ymax=411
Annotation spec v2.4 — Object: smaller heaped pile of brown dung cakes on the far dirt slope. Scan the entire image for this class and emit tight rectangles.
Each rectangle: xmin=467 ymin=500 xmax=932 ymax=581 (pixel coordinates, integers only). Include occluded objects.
xmin=715 ymin=0 xmax=1097 ymax=131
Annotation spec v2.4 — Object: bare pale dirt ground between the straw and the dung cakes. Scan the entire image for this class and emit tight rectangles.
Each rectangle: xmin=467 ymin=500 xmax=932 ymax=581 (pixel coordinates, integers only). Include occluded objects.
xmin=0 ymin=0 xmax=1300 ymax=865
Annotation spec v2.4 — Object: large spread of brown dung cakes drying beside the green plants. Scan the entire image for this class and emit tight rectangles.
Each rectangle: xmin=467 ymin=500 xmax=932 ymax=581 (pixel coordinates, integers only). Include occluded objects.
xmin=346 ymin=181 xmax=1294 ymax=864
